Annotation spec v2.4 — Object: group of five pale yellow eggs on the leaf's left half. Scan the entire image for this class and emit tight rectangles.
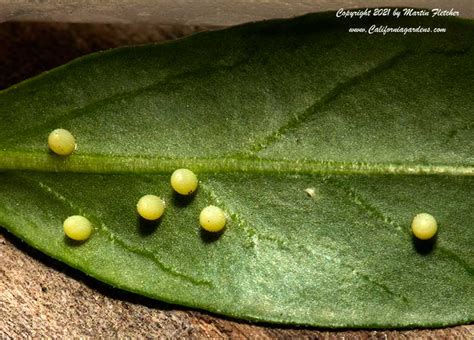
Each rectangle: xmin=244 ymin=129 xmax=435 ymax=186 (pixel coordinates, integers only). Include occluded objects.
xmin=48 ymin=129 xmax=226 ymax=241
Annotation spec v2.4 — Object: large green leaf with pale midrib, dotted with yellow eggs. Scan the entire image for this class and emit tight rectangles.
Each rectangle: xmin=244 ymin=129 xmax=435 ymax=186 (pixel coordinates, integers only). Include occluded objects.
xmin=0 ymin=13 xmax=474 ymax=327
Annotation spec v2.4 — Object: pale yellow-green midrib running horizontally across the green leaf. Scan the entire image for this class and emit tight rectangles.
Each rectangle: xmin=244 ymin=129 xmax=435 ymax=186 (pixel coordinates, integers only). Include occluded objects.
xmin=0 ymin=151 xmax=474 ymax=176
